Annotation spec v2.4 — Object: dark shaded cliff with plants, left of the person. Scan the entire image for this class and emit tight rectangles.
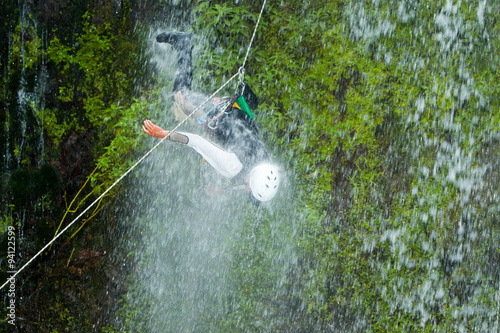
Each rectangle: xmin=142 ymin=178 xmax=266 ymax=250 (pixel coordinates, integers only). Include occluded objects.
xmin=0 ymin=1 xmax=164 ymax=331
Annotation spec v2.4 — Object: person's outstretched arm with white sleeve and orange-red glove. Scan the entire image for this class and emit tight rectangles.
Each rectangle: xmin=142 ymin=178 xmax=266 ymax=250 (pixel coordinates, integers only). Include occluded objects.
xmin=142 ymin=120 xmax=243 ymax=178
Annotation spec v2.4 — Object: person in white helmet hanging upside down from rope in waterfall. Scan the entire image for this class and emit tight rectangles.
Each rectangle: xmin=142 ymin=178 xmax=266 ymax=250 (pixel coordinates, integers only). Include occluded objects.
xmin=142 ymin=32 xmax=280 ymax=205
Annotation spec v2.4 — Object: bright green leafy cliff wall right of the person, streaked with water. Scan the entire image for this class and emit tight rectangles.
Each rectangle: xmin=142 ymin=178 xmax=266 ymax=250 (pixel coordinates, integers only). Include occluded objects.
xmin=187 ymin=1 xmax=499 ymax=332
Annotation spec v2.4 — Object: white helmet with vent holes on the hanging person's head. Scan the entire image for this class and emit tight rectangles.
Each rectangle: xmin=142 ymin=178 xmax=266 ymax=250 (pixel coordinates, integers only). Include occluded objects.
xmin=249 ymin=163 xmax=280 ymax=201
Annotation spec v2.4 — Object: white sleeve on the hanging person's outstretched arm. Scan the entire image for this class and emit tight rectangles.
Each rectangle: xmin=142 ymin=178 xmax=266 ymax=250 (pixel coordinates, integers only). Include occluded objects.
xmin=179 ymin=132 xmax=243 ymax=178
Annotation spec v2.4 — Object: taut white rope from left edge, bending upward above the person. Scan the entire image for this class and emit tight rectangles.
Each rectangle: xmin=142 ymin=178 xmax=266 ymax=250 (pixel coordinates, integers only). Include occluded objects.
xmin=0 ymin=0 xmax=267 ymax=290
